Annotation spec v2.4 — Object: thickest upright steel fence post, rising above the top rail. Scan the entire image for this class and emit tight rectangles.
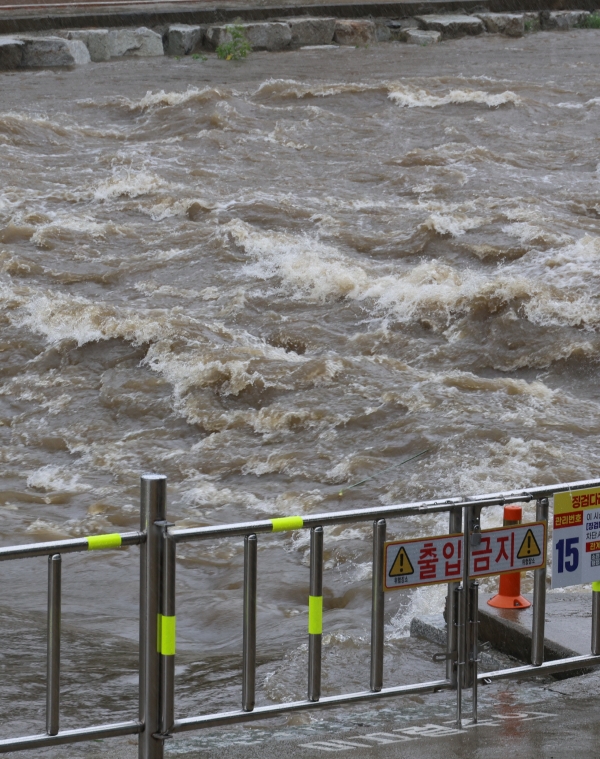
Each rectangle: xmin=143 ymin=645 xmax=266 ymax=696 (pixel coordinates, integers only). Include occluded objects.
xmin=139 ymin=474 xmax=167 ymax=759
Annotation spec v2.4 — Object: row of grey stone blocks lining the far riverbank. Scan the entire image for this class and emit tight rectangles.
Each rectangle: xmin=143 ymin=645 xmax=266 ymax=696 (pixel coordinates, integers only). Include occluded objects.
xmin=0 ymin=11 xmax=590 ymax=70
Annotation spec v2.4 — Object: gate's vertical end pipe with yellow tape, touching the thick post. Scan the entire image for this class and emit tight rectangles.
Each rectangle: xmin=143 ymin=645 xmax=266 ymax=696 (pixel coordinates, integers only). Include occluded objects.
xmin=159 ymin=523 xmax=177 ymax=736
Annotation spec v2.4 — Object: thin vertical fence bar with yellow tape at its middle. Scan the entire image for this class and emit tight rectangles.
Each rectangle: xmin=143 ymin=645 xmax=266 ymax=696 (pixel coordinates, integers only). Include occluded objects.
xmin=308 ymin=527 xmax=323 ymax=701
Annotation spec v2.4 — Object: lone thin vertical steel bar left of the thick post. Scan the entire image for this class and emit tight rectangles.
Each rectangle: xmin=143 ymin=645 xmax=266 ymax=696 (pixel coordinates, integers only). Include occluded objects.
xmin=46 ymin=554 xmax=62 ymax=735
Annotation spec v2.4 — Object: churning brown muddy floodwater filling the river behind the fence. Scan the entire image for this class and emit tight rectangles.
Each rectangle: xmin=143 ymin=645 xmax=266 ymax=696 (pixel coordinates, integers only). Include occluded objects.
xmin=0 ymin=30 xmax=600 ymax=757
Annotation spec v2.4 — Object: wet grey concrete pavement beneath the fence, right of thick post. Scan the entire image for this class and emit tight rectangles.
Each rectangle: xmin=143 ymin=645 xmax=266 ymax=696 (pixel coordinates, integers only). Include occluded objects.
xmin=167 ymin=674 xmax=600 ymax=759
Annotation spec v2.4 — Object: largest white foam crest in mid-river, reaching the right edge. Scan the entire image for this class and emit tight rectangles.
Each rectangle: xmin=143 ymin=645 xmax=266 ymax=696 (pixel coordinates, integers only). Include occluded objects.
xmin=221 ymin=215 xmax=600 ymax=329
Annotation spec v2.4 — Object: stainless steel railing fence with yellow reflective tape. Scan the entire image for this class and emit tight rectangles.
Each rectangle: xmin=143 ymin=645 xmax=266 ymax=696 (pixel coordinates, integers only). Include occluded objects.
xmin=0 ymin=474 xmax=600 ymax=759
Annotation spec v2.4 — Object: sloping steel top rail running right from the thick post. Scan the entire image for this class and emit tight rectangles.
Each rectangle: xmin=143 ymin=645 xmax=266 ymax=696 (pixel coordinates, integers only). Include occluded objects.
xmin=171 ymin=480 xmax=600 ymax=543
